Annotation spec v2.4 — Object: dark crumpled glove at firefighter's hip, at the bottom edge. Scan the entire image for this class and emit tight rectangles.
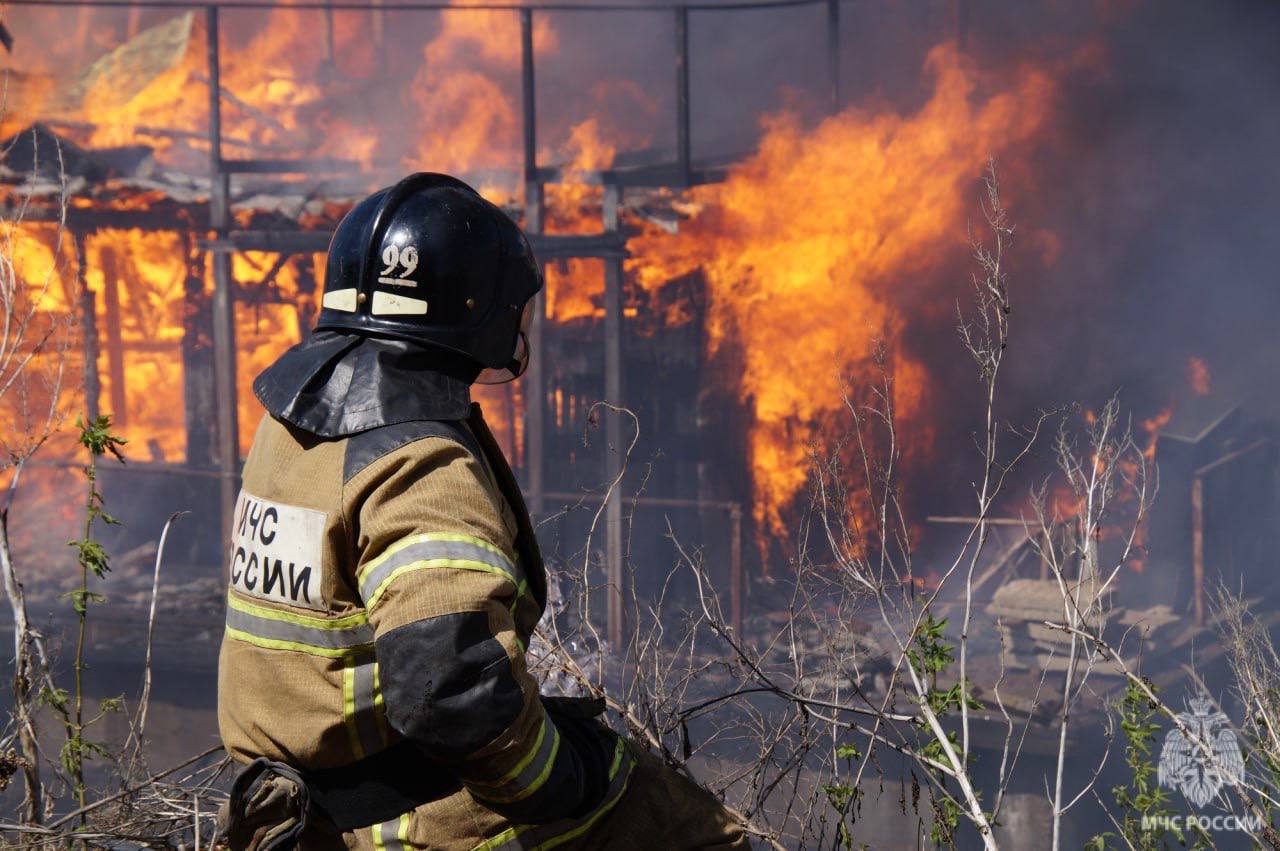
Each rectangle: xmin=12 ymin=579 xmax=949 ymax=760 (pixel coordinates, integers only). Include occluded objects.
xmin=218 ymin=759 xmax=311 ymax=851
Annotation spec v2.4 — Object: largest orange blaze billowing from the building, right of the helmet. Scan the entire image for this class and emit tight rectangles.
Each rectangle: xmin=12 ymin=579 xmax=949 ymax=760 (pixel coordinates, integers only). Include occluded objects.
xmin=630 ymin=46 xmax=1053 ymax=532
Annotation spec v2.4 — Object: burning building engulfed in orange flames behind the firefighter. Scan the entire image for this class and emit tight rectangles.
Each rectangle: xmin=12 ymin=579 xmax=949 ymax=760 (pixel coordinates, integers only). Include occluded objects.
xmin=3 ymin=0 xmax=1280 ymax=655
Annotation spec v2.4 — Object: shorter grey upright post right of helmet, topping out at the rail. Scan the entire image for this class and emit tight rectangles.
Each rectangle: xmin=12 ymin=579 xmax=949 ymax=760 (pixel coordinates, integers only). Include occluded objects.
xmin=602 ymin=183 xmax=628 ymax=651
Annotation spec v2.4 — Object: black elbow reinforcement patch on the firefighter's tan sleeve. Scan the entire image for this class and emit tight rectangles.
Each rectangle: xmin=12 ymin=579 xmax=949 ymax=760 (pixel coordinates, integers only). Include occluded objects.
xmin=376 ymin=612 xmax=525 ymax=761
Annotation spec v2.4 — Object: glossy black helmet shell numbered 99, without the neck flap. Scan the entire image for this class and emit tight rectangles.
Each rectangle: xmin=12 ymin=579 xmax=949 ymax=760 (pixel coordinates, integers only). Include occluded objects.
xmin=316 ymin=173 xmax=543 ymax=380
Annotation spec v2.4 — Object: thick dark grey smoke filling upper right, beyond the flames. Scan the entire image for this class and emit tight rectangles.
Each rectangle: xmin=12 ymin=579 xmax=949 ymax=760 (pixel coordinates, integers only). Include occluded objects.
xmin=977 ymin=1 xmax=1280 ymax=415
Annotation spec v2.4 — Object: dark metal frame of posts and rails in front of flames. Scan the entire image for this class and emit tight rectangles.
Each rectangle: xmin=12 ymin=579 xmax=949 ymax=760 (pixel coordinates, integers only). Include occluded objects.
xmin=13 ymin=0 xmax=841 ymax=646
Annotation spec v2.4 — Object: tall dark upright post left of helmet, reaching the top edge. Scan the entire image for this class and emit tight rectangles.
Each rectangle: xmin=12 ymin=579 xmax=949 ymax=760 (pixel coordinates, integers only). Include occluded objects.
xmin=205 ymin=6 xmax=241 ymax=535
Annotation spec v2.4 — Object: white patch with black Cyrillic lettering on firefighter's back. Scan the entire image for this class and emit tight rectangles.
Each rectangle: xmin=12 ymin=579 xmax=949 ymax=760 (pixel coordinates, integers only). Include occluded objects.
xmin=230 ymin=490 xmax=325 ymax=609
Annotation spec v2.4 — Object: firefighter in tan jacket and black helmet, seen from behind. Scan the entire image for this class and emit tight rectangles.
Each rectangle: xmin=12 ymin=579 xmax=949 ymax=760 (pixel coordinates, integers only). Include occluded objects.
xmin=218 ymin=174 xmax=749 ymax=851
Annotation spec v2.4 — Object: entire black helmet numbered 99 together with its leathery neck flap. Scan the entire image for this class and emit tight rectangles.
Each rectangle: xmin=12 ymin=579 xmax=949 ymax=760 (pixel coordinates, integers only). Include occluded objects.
xmin=253 ymin=173 xmax=543 ymax=438
